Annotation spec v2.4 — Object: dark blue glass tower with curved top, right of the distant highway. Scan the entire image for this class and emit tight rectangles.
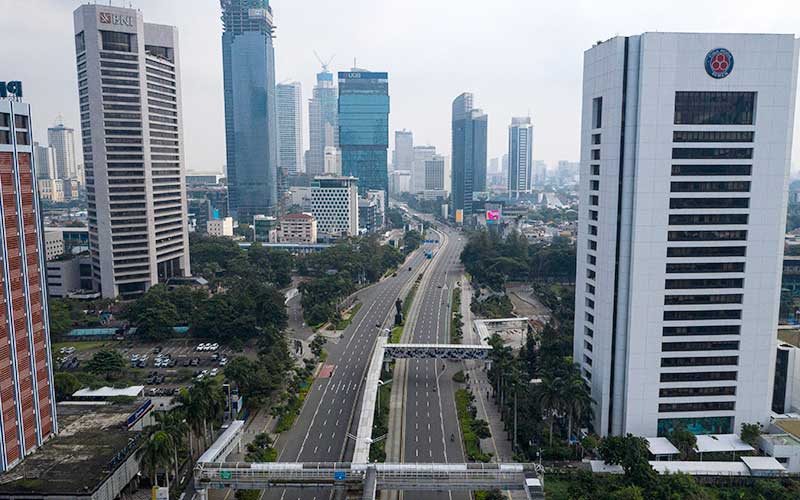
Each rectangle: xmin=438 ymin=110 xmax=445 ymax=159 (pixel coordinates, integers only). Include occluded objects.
xmin=451 ymin=92 xmax=488 ymax=218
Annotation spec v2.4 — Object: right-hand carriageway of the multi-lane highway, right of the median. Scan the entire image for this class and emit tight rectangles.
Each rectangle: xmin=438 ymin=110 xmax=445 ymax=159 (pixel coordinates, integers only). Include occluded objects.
xmin=400 ymin=229 xmax=467 ymax=499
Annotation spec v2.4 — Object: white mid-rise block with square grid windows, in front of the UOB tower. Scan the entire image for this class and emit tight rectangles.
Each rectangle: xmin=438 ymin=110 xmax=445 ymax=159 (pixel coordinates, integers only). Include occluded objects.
xmin=311 ymin=176 xmax=358 ymax=236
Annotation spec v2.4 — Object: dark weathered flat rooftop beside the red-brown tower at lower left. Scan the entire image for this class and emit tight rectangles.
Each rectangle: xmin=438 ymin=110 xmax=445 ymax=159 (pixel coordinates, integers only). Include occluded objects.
xmin=0 ymin=402 xmax=141 ymax=497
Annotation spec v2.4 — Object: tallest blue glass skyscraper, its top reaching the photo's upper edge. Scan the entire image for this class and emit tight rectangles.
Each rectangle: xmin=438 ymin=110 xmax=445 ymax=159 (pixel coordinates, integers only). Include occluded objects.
xmin=220 ymin=0 xmax=279 ymax=222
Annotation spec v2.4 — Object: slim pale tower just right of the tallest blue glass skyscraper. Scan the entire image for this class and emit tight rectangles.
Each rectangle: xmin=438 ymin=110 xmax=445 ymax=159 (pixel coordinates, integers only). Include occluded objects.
xmin=275 ymin=82 xmax=303 ymax=175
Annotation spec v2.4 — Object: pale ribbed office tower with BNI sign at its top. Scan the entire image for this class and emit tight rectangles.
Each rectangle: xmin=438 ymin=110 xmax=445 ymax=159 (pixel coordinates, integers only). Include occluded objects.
xmin=74 ymin=5 xmax=194 ymax=298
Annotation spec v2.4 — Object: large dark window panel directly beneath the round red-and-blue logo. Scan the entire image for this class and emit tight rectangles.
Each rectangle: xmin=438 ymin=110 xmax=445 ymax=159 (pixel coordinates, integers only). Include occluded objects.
xmin=674 ymin=92 xmax=756 ymax=125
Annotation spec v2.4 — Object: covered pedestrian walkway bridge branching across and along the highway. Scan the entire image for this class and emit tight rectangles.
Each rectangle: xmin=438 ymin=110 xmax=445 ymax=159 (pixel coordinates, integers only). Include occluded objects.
xmin=194 ymin=336 xmax=544 ymax=500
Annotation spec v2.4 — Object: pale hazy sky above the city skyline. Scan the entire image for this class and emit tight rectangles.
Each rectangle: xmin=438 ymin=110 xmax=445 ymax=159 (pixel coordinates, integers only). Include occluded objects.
xmin=0 ymin=0 xmax=800 ymax=171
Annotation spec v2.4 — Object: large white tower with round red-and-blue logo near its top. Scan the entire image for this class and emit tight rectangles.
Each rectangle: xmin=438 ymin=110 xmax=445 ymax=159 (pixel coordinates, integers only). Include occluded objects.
xmin=574 ymin=33 xmax=798 ymax=437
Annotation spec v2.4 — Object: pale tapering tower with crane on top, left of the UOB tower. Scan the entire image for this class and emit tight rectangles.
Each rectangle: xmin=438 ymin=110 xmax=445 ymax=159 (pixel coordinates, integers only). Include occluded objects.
xmin=306 ymin=66 xmax=339 ymax=175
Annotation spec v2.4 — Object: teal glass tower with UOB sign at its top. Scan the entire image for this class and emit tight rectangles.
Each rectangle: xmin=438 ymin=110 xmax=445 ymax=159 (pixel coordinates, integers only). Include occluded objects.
xmin=339 ymin=68 xmax=389 ymax=194
